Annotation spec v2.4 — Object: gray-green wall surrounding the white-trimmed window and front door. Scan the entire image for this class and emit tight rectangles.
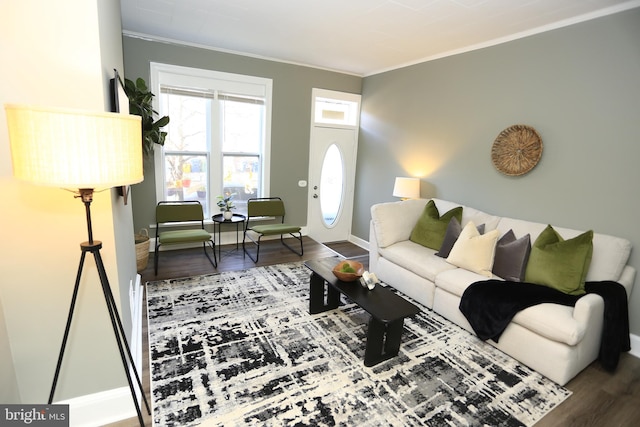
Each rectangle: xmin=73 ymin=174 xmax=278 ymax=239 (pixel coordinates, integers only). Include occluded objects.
xmin=123 ymin=37 xmax=362 ymax=234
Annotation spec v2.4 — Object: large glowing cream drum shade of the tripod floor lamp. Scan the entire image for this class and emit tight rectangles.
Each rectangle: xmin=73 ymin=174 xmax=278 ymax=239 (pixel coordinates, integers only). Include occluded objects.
xmin=5 ymin=105 xmax=144 ymax=189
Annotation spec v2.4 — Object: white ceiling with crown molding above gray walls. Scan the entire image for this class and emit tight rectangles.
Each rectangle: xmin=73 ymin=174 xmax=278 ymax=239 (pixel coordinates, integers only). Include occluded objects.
xmin=121 ymin=0 xmax=640 ymax=76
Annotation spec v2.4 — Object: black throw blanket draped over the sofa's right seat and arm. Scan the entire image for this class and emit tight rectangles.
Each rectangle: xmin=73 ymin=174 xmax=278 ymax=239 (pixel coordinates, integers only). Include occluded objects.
xmin=460 ymin=280 xmax=631 ymax=371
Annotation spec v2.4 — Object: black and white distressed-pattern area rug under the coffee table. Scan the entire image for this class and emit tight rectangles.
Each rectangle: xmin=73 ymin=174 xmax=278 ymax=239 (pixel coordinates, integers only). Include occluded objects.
xmin=147 ymin=263 xmax=571 ymax=426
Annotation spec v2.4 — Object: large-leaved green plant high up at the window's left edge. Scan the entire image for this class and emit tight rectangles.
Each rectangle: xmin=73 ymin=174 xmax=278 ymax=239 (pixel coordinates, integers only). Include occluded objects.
xmin=121 ymin=77 xmax=169 ymax=157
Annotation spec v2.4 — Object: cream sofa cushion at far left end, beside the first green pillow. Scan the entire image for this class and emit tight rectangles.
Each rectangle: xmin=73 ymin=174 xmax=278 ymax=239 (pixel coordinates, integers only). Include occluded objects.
xmin=371 ymin=199 xmax=427 ymax=248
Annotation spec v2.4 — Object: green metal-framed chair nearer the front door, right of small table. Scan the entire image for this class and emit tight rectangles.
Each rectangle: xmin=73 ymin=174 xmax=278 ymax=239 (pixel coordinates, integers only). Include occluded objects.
xmin=242 ymin=197 xmax=304 ymax=262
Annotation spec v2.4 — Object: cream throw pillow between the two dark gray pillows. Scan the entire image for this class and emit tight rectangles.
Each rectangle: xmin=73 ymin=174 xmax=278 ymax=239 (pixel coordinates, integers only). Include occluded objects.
xmin=447 ymin=221 xmax=499 ymax=277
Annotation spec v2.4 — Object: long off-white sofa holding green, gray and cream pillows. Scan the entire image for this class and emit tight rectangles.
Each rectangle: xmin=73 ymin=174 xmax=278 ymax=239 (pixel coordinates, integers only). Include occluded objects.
xmin=369 ymin=199 xmax=635 ymax=385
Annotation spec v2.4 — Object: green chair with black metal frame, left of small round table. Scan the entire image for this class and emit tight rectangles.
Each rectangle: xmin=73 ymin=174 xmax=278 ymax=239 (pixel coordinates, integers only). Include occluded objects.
xmin=154 ymin=201 xmax=218 ymax=275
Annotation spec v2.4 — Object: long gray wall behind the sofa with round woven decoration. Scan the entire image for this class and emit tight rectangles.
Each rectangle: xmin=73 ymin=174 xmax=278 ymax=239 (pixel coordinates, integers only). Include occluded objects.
xmin=353 ymin=9 xmax=640 ymax=335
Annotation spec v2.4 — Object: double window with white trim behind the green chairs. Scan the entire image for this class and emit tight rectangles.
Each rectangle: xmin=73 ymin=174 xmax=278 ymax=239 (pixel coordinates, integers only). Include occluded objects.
xmin=151 ymin=63 xmax=272 ymax=217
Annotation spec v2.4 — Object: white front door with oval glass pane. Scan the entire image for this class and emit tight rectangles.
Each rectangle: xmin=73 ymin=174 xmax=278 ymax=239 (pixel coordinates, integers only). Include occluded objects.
xmin=307 ymin=126 xmax=358 ymax=243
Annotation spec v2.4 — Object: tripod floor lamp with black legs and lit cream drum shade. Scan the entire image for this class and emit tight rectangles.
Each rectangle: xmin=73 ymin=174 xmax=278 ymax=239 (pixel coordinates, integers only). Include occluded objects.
xmin=5 ymin=105 xmax=151 ymax=425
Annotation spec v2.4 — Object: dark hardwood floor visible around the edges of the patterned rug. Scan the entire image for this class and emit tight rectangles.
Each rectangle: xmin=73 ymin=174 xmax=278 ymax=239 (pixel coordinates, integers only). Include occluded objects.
xmin=109 ymin=237 xmax=640 ymax=427
